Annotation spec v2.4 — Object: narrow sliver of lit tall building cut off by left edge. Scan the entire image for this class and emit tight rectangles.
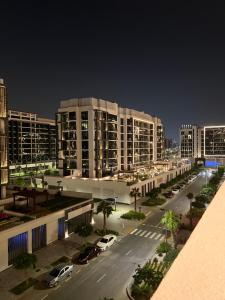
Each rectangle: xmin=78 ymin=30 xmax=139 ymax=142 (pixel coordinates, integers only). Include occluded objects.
xmin=0 ymin=79 xmax=8 ymax=199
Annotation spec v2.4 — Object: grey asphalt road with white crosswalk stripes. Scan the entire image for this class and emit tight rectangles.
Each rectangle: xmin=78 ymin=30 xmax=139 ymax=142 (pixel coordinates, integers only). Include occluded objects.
xmin=47 ymin=174 xmax=209 ymax=300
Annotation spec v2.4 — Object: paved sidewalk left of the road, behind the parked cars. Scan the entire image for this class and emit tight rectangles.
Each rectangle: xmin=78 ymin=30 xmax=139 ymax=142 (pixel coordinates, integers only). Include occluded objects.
xmin=0 ymin=198 xmax=151 ymax=300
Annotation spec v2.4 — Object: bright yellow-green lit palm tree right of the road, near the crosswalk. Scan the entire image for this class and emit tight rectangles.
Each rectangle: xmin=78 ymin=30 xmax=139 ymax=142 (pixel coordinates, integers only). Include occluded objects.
xmin=160 ymin=210 xmax=180 ymax=248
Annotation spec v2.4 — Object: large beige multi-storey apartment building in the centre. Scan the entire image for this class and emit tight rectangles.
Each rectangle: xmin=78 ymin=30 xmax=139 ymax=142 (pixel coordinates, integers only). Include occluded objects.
xmin=56 ymin=98 xmax=164 ymax=178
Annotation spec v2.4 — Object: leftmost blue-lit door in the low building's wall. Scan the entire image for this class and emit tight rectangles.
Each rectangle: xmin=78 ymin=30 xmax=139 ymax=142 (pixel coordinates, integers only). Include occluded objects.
xmin=8 ymin=232 xmax=28 ymax=265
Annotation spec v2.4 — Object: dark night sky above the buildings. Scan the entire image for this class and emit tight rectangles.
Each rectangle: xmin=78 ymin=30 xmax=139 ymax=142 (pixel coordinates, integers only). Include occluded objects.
xmin=0 ymin=0 xmax=225 ymax=137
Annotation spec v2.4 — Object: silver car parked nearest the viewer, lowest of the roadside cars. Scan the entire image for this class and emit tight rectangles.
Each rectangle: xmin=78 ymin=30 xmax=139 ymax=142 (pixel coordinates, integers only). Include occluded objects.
xmin=45 ymin=264 xmax=73 ymax=288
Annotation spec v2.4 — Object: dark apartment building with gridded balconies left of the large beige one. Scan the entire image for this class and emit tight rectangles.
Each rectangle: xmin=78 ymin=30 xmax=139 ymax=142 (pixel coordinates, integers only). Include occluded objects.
xmin=8 ymin=110 xmax=56 ymax=170
